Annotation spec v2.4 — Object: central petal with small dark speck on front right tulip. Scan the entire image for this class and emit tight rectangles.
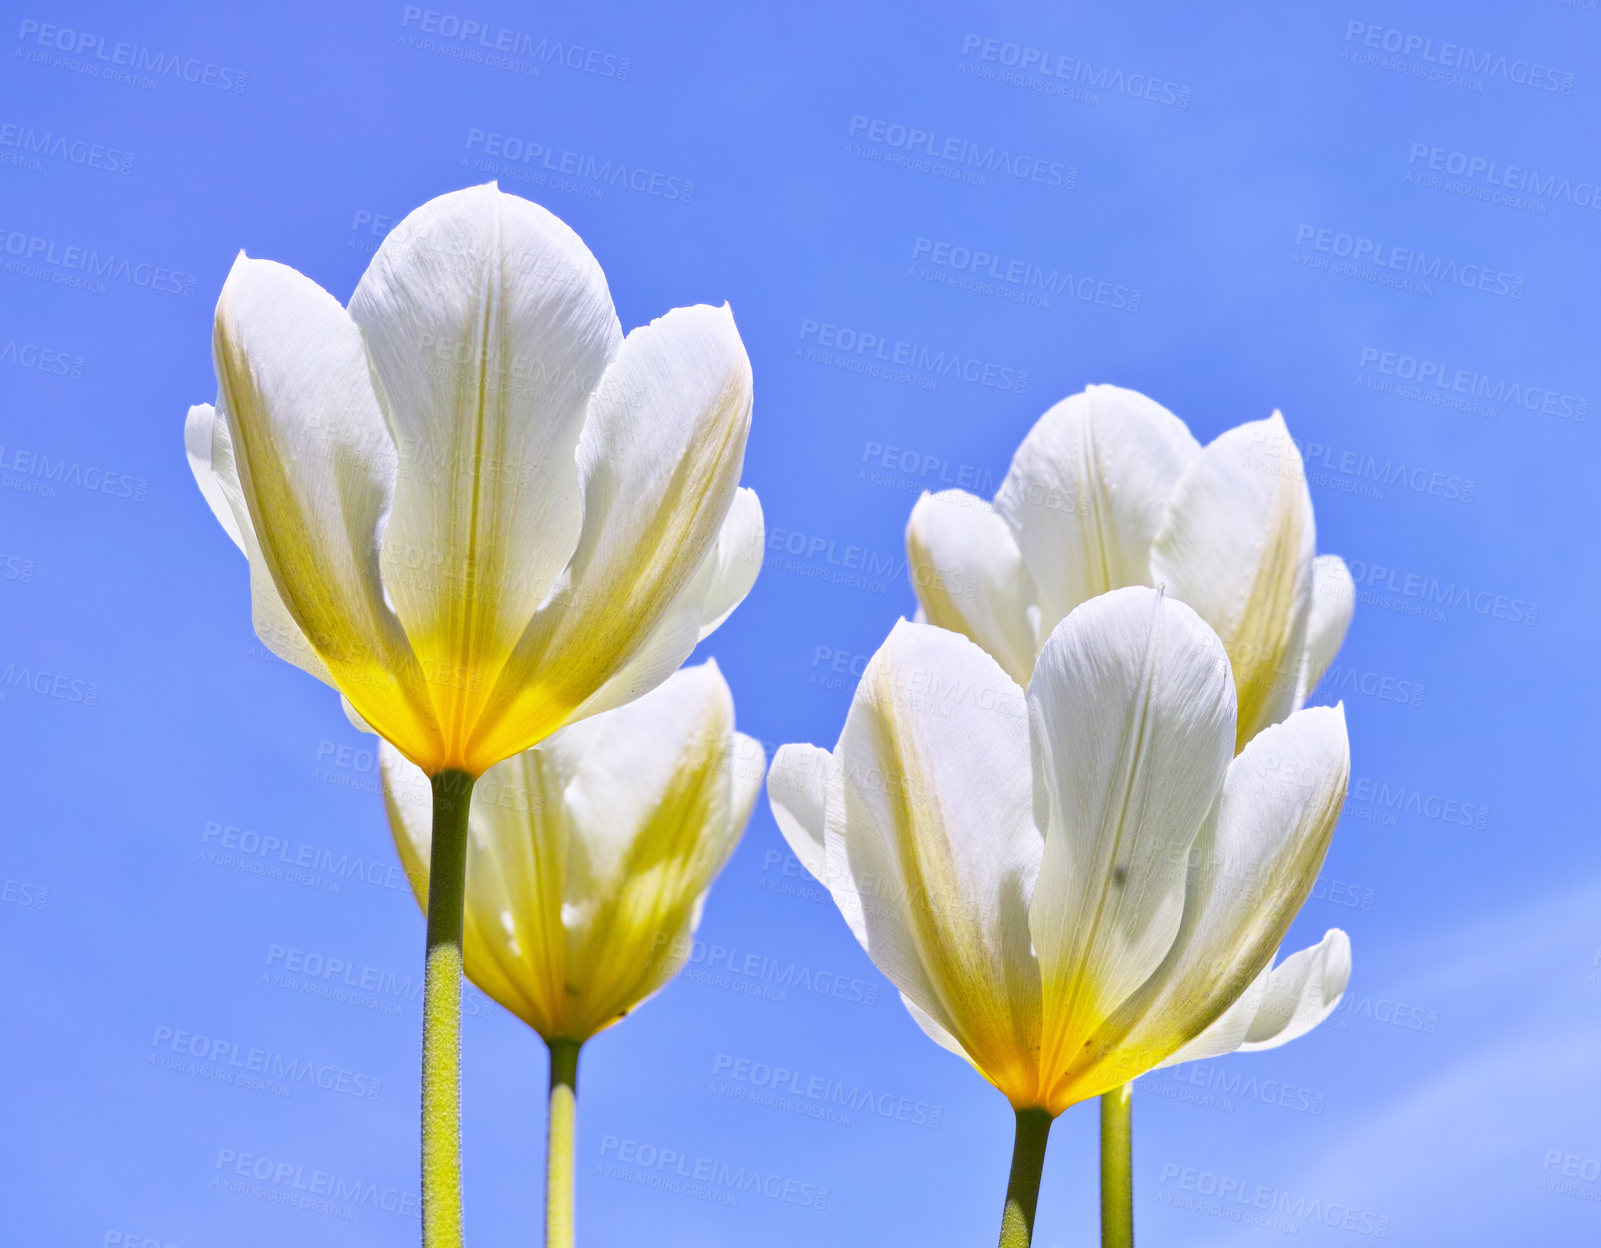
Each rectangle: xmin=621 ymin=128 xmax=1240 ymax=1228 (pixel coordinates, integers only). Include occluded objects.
xmin=1028 ymin=587 xmax=1234 ymax=1088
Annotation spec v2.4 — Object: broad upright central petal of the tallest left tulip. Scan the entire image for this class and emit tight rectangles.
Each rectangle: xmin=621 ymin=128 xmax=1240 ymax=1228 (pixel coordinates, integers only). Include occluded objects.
xmin=351 ymin=184 xmax=621 ymax=710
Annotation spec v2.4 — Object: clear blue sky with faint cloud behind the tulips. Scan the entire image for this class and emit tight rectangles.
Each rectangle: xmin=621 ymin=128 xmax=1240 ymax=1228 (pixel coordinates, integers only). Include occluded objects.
xmin=0 ymin=0 xmax=1601 ymax=1248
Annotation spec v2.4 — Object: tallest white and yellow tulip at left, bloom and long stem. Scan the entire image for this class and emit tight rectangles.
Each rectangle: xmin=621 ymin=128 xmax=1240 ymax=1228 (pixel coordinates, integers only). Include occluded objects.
xmin=184 ymin=184 xmax=762 ymax=1245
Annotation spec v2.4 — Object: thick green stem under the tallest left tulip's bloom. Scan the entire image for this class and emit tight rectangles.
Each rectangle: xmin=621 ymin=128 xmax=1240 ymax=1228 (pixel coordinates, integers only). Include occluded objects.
xmin=423 ymin=771 xmax=474 ymax=1248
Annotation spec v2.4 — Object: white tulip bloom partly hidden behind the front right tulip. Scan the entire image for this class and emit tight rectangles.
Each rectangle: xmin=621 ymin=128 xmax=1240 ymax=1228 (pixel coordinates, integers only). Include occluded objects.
xmin=906 ymin=386 xmax=1354 ymax=749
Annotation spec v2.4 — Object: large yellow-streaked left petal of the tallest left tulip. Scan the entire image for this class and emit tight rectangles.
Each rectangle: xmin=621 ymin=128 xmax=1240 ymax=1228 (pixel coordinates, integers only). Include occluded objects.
xmin=213 ymin=254 xmax=439 ymax=758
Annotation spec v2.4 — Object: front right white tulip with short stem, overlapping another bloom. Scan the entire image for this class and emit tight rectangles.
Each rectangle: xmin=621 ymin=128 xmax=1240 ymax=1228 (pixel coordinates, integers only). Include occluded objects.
xmin=767 ymin=587 xmax=1350 ymax=1245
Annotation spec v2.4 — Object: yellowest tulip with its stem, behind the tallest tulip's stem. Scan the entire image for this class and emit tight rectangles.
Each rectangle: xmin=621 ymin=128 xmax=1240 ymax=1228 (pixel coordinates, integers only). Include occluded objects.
xmin=381 ymin=662 xmax=765 ymax=1248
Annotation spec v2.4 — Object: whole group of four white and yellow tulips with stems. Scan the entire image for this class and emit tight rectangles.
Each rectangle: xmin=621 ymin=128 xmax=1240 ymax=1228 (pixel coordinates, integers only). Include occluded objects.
xmin=193 ymin=184 xmax=1354 ymax=1248
